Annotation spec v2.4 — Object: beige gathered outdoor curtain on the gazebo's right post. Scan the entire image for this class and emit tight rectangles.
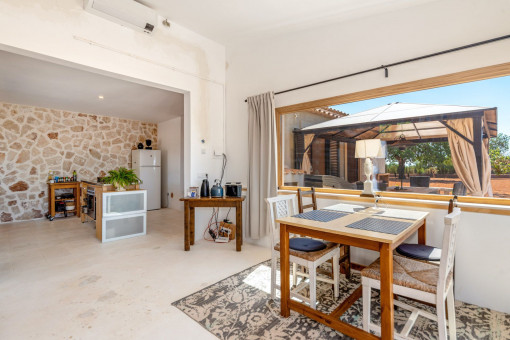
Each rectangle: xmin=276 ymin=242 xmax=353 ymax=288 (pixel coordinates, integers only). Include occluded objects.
xmin=446 ymin=118 xmax=492 ymax=196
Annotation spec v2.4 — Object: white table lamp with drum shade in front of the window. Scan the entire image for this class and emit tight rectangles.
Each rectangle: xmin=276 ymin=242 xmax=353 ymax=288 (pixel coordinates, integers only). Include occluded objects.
xmin=355 ymin=139 xmax=386 ymax=197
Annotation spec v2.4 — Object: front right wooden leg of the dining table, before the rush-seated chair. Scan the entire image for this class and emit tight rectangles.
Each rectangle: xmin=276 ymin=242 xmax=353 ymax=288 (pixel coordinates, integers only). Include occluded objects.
xmin=380 ymin=244 xmax=394 ymax=339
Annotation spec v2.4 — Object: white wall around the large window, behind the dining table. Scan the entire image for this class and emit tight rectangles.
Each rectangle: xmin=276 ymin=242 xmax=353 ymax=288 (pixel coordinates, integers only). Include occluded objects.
xmin=226 ymin=0 xmax=510 ymax=312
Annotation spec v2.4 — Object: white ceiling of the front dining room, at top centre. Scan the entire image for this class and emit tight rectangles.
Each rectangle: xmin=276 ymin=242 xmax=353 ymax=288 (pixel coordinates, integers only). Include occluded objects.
xmin=139 ymin=0 xmax=438 ymax=44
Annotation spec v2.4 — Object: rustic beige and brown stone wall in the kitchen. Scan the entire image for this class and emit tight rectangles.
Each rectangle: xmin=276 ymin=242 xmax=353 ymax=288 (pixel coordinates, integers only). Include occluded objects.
xmin=0 ymin=102 xmax=157 ymax=223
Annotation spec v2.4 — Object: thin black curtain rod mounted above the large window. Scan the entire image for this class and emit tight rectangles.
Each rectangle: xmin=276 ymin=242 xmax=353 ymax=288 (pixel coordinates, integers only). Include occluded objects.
xmin=244 ymin=34 xmax=510 ymax=103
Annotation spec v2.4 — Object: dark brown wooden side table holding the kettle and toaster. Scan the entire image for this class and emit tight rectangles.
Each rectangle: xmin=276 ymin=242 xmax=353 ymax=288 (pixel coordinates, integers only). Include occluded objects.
xmin=180 ymin=196 xmax=246 ymax=251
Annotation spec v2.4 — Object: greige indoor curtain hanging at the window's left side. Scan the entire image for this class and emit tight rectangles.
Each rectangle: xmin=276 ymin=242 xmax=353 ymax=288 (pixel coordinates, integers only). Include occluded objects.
xmin=247 ymin=92 xmax=277 ymax=240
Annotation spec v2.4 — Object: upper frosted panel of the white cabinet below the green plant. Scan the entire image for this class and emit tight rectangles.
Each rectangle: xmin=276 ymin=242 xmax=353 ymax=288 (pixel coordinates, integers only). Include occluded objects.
xmin=103 ymin=191 xmax=146 ymax=216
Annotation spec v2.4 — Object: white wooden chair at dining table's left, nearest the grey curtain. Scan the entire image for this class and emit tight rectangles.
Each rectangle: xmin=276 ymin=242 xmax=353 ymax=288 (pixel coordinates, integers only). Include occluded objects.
xmin=266 ymin=195 xmax=340 ymax=309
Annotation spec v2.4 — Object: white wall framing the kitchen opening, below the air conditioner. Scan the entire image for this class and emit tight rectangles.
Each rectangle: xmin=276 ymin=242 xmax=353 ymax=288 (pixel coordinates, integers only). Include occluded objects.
xmin=0 ymin=0 xmax=225 ymax=239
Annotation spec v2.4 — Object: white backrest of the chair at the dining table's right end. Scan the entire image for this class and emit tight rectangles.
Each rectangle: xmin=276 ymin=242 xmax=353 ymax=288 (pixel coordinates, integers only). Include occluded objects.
xmin=437 ymin=208 xmax=460 ymax=293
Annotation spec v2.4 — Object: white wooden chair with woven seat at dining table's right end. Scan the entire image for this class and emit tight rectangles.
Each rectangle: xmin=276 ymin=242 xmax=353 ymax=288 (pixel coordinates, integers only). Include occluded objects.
xmin=361 ymin=208 xmax=460 ymax=340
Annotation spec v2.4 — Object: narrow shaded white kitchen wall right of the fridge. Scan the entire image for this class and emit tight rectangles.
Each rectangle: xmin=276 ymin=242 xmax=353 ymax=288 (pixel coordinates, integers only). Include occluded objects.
xmin=158 ymin=117 xmax=184 ymax=210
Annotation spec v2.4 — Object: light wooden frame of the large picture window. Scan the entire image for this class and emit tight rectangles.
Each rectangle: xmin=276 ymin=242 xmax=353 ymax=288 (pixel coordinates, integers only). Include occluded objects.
xmin=275 ymin=63 xmax=510 ymax=215
